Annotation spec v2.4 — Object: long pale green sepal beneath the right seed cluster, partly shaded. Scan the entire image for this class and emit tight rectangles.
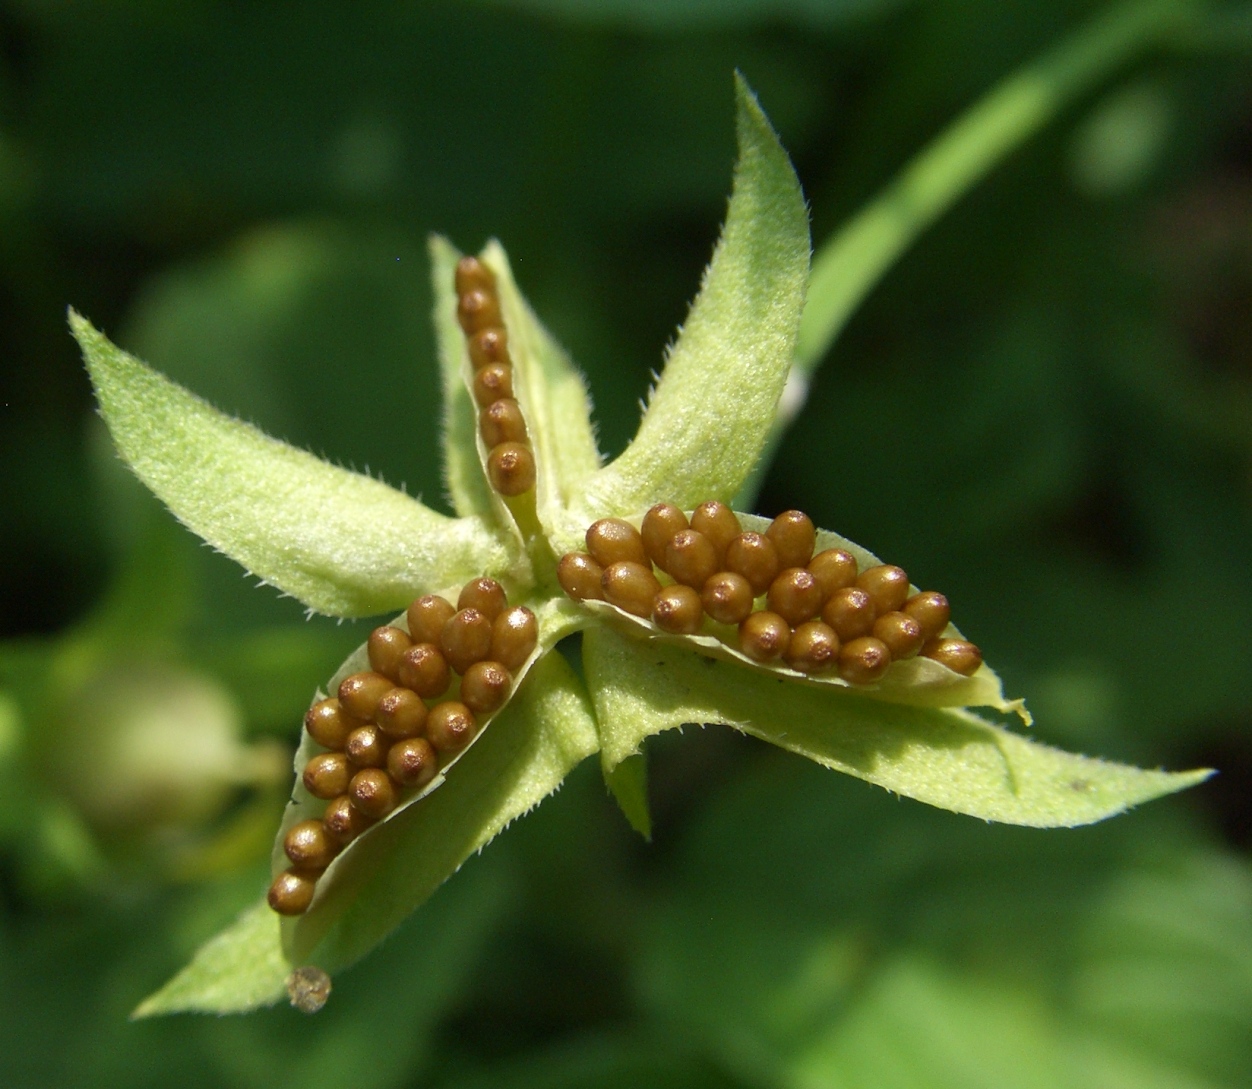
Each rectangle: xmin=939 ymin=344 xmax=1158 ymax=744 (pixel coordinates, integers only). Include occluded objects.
xmin=582 ymin=627 xmax=1211 ymax=827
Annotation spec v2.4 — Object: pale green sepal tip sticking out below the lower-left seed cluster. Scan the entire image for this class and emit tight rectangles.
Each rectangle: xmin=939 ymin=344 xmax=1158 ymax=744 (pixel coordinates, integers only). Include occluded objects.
xmin=130 ymin=900 xmax=292 ymax=1018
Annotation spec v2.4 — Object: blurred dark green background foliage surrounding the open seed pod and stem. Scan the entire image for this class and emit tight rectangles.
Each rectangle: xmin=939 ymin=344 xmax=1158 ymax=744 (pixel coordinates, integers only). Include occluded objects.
xmin=0 ymin=0 xmax=1252 ymax=1089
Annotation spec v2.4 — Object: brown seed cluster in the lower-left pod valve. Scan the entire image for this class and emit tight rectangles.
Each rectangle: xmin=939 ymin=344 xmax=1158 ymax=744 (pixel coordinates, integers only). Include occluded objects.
xmin=269 ymin=578 xmax=538 ymax=915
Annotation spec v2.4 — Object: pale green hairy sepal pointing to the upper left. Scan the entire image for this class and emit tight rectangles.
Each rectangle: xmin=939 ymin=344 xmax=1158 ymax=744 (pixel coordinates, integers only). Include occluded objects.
xmin=70 ymin=310 xmax=510 ymax=616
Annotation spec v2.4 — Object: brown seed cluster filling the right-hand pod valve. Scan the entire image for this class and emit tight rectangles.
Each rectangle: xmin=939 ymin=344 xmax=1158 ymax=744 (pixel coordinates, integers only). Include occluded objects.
xmin=557 ymin=501 xmax=983 ymax=685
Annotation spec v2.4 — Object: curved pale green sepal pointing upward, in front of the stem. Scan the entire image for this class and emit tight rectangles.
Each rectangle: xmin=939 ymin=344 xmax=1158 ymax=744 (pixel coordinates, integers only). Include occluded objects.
xmin=578 ymin=78 xmax=809 ymax=526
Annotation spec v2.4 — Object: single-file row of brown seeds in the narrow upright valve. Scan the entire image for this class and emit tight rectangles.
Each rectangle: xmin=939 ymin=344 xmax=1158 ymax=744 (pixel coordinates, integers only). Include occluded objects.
xmin=456 ymin=257 xmax=535 ymax=496
